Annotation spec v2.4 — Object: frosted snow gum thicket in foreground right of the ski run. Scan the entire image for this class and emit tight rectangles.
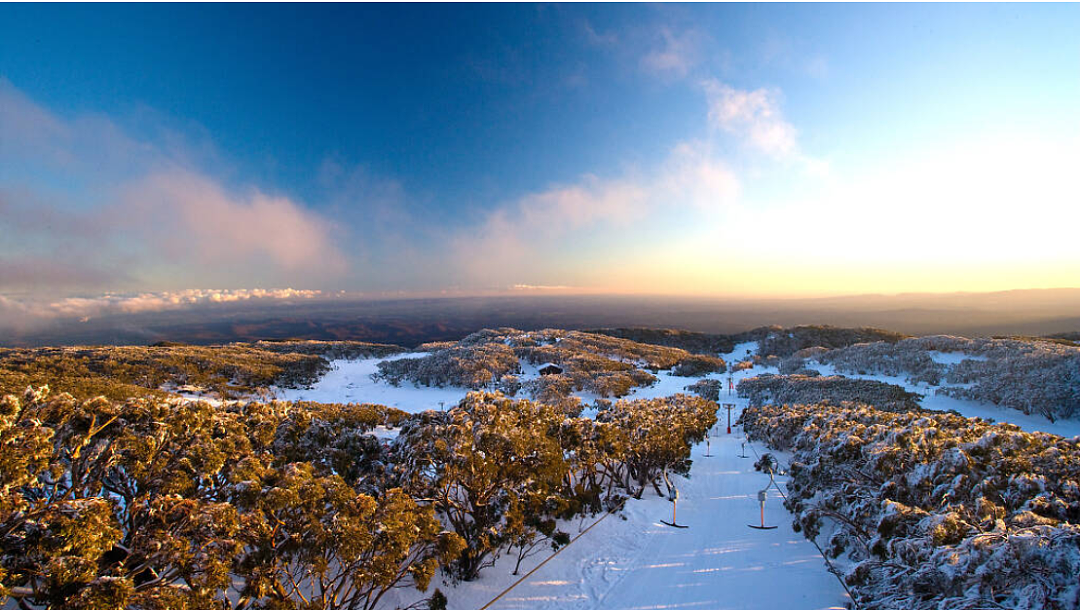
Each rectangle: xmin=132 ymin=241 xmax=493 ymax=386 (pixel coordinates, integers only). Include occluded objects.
xmin=741 ymin=404 xmax=1080 ymax=610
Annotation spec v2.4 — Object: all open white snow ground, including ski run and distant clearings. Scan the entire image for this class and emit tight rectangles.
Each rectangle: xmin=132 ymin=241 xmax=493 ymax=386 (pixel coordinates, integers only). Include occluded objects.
xmin=248 ymin=342 xmax=1080 ymax=610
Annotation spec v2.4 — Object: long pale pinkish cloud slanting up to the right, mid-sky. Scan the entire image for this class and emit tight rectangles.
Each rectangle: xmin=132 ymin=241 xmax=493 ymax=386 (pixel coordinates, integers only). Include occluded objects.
xmin=450 ymin=143 xmax=740 ymax=287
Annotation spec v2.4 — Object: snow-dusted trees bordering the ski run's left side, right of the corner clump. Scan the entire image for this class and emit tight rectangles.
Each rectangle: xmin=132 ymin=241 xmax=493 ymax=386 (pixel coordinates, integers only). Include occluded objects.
xmin=391 ymin=390 xmax=716 ymax=580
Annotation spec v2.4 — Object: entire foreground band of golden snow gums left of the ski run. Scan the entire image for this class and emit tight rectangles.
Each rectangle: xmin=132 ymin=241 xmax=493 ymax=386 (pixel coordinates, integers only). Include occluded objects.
xmin=0 ymin=388 xmax=716 ymax=610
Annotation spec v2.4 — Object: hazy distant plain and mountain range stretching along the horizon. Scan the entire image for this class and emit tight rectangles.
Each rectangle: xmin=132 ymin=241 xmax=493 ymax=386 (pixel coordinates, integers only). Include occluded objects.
xmin=0 ymin=288 xmax=1080 ymax=347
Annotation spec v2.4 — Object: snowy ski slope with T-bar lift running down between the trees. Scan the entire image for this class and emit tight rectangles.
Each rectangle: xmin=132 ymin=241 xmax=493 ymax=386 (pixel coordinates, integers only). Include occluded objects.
xmin=477 ymin=399 xmax=848 ymax=610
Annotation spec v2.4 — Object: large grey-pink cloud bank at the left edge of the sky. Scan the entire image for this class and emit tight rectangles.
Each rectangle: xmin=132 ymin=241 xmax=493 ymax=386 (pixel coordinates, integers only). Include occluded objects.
xmin=0 ymin=79 xmax=348 ymax=293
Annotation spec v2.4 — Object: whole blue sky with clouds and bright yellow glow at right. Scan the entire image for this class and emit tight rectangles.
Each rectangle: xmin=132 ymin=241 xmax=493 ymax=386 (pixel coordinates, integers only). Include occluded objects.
xmin=0 ymin=3 xmax=1080 ymax=313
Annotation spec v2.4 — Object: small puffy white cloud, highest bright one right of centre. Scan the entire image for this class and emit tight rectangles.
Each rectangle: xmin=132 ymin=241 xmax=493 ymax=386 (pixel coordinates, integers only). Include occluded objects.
xmin=702 ymin=79 xmax=798 ymax=158
